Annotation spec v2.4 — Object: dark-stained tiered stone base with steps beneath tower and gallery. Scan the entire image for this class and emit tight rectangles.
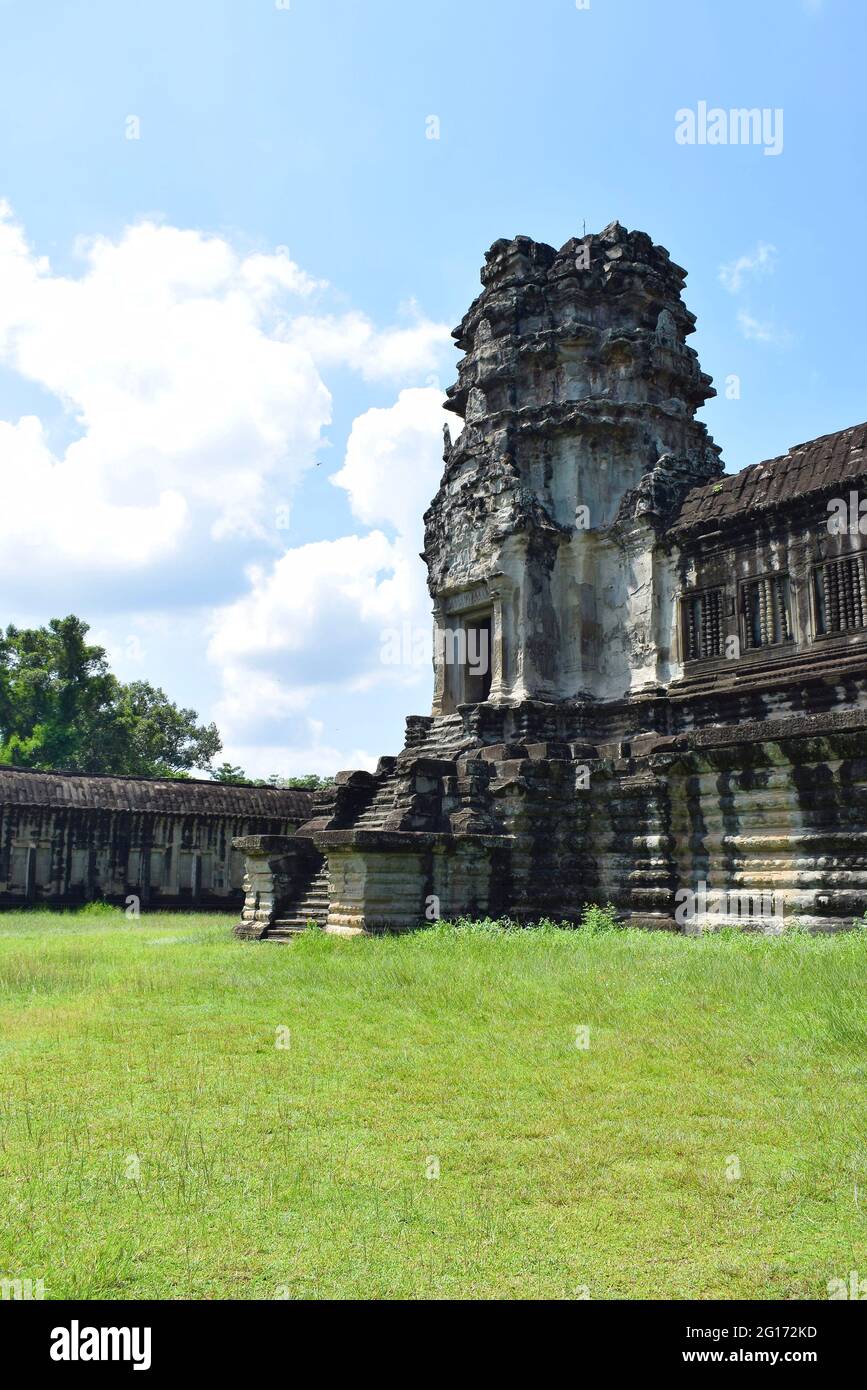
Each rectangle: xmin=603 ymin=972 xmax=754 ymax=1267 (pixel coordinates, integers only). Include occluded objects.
xmin=238 ymin=705 xmax=867 ymax=937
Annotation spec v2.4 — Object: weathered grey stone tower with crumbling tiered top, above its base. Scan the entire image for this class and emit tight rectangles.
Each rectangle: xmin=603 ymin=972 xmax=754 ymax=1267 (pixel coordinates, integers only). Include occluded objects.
xmin=424 ymin=222 xmax=723 ymax=714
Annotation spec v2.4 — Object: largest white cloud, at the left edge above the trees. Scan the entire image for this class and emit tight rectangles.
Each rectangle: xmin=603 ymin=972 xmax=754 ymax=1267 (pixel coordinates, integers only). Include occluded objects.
xmin=0 ymin=203 xmax=449 ymax=588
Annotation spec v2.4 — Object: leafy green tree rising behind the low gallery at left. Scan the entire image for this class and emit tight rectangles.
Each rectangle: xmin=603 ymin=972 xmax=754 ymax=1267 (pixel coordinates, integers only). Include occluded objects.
xmin=0 ymin=616 xmax=222 ymax=777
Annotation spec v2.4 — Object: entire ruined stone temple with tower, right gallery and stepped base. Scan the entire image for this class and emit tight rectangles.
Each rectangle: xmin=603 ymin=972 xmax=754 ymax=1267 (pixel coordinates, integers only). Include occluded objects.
xmin=238 ymin=222 xmax=867 ymax=938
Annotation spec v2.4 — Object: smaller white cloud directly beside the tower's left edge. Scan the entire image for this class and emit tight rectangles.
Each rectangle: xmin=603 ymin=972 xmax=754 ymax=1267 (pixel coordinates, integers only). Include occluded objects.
xmin=208 ymin=386 xmax=446 ymax=766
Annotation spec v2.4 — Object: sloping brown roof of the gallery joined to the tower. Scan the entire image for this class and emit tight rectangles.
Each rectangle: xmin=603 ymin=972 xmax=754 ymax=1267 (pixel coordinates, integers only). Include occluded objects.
xmin=672 ymin=424 xmax=867 ymax=531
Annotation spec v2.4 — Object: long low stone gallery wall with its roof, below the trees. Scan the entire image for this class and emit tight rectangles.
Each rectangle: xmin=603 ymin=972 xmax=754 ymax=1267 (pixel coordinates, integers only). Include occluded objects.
xmin=0 ymin=767 xmax=310 ymax=908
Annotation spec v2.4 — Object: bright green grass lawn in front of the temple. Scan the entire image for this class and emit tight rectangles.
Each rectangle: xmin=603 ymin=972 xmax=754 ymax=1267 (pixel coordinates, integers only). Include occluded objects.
xmin=0 ymin=912 xmax=867 ymax=1298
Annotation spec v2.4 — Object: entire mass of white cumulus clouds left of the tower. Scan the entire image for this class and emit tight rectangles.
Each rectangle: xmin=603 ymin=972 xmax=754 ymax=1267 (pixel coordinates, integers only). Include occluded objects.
xmin=0 ymin=203 xmax=452 ymax=773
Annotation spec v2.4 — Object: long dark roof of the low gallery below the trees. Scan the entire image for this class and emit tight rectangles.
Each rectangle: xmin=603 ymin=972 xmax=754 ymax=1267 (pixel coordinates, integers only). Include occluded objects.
xmin=0 ymin=763 xmax=313 ymax=820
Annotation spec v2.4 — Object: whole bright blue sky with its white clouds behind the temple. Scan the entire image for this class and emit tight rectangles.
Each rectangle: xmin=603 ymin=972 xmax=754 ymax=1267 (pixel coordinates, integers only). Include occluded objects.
xmin=0 ymin=0 xmax=867 ymax=774
